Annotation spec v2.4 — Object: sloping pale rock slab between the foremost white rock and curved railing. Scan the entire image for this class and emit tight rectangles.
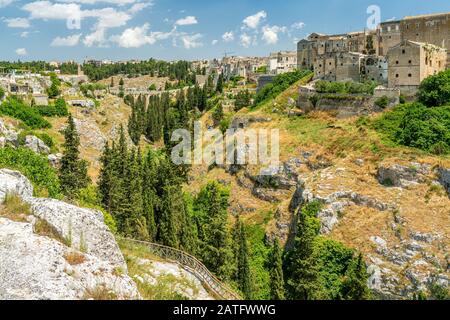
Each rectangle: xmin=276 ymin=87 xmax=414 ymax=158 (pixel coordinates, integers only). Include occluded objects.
xmin=29 ymin=198 xmax=126 ymax=270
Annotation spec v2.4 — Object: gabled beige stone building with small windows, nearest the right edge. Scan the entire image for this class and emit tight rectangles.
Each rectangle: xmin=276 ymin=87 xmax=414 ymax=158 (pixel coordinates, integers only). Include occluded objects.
xmin=387 ymin=40 xmax=447 ymax=93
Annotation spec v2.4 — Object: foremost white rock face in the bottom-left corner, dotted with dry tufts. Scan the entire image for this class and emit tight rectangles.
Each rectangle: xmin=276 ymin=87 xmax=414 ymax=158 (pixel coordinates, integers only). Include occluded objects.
xmin=0 ymin=218 xmax=139 ymax=300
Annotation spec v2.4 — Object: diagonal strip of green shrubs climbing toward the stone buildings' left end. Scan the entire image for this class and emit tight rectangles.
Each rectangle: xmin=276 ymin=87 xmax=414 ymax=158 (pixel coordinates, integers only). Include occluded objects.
xmin=254 ymin=70 xmax=311 ymax=107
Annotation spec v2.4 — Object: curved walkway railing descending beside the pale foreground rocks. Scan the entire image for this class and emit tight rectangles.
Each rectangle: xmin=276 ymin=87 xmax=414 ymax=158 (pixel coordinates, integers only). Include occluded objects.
xmin=121 ymin=238 xmax=242 ymax=300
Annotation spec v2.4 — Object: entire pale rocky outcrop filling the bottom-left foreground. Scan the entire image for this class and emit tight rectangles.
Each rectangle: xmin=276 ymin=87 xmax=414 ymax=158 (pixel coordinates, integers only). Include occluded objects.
xmin=0 ymin=169 xmax=135 ymax=299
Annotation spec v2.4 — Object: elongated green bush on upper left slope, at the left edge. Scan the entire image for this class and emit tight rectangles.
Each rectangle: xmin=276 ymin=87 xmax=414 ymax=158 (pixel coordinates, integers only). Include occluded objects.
xmin=0 ymin=97 xmax=51 ymax=129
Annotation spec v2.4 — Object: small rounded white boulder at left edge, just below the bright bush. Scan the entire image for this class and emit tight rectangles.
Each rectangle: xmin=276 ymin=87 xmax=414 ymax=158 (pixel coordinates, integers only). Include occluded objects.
xmin=0 ymin=169 xmax=33 ymax=203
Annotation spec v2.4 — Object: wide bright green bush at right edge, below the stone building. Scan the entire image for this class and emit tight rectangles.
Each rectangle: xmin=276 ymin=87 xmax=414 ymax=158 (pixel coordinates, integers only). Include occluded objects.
xmin=374 ymin=103 xmax=450 ymax=154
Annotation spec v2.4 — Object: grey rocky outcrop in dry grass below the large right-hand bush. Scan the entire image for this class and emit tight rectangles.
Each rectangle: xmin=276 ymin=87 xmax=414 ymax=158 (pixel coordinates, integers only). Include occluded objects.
xmin=377 ymin=163 xmax=431 ymax=188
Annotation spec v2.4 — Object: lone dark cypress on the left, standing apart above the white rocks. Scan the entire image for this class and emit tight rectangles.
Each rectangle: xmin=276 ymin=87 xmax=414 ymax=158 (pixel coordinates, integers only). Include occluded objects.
xmin=59 ymin=115 xmax=90 ymax=198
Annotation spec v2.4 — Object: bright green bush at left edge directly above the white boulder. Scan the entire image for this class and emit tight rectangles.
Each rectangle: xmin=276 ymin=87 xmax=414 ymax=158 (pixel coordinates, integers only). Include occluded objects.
xmin=0 ymin=147 xmax=60 ymax=198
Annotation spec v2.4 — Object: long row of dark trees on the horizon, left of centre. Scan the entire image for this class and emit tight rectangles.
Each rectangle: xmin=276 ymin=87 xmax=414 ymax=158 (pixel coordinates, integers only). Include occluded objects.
xmin=83 ymin=59 xmax=195 ymax=84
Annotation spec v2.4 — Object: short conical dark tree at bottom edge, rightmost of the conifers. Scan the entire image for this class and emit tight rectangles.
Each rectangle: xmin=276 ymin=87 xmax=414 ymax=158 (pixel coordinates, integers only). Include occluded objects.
xmin=341 ymin=254 xmax=370 ymax=300
